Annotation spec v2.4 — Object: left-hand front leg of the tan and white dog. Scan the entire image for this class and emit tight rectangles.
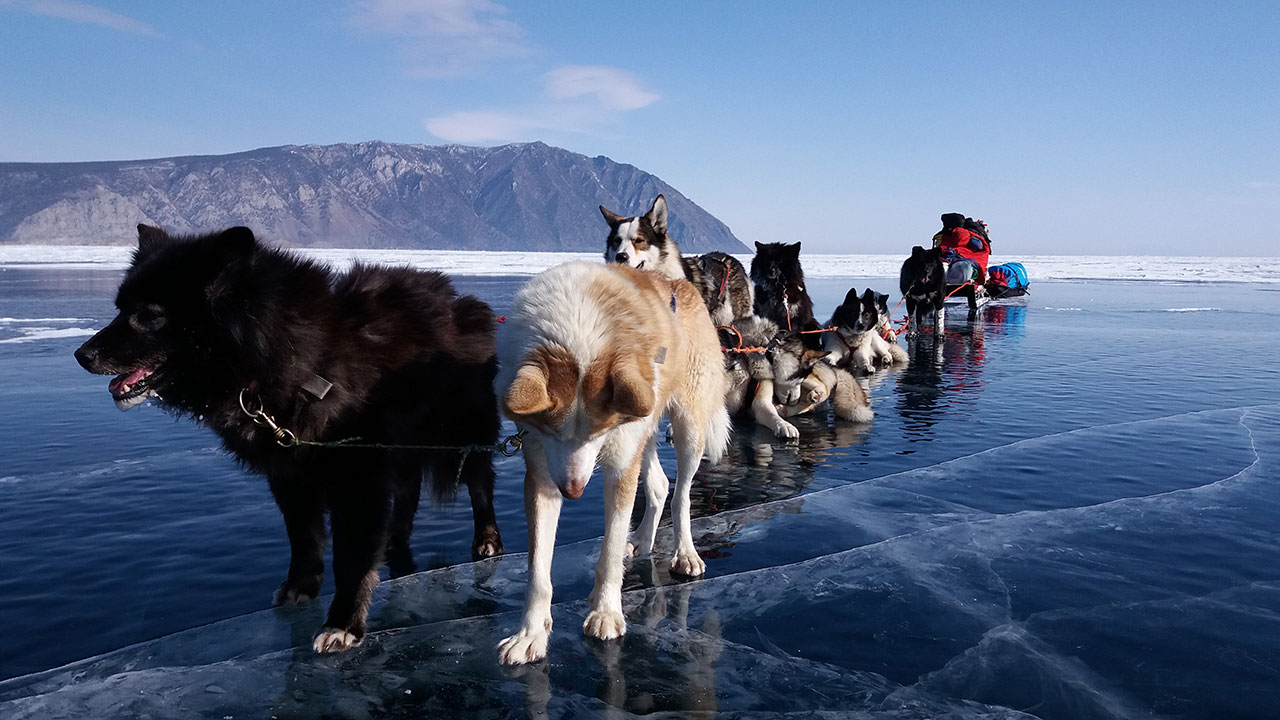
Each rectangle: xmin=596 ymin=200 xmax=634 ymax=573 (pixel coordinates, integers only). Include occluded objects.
xmin=498 ymin=438 xmax=562 ymax=665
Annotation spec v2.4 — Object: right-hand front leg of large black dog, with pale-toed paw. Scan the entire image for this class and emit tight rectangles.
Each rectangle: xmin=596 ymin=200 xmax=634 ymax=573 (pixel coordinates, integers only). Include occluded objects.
xmin=311 ymin=478 xmax=389 ymax=652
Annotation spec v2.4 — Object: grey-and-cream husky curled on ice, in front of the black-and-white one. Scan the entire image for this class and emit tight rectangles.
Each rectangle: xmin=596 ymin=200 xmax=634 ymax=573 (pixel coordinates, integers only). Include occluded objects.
xmin=765 ymin=333 xmax=872 ymax=423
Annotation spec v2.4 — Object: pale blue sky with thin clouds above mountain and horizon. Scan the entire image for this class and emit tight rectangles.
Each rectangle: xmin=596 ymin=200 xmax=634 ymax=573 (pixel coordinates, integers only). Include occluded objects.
xmin=0 ymin=0 xmax=1280 ymax=259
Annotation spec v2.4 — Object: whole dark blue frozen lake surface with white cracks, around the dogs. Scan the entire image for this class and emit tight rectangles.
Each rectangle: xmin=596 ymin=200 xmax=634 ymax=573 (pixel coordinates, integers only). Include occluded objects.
xmin=0 ymin=269 xmax=1280 ymax=719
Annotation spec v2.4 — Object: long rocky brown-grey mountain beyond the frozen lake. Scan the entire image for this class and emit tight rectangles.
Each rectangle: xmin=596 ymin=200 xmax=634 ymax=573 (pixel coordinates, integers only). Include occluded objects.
xmin=0 ymin=141 xmax=744 ymax=252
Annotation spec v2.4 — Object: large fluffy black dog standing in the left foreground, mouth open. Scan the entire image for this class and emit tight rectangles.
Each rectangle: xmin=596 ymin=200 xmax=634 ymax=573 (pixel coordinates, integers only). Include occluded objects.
xmin=76 ymin=225 xmax=502 ymax=651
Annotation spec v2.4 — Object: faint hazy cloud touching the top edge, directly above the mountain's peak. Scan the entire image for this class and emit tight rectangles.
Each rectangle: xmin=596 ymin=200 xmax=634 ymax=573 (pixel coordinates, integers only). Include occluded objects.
xmin=348 ymin=0 xmax=532 ymax=77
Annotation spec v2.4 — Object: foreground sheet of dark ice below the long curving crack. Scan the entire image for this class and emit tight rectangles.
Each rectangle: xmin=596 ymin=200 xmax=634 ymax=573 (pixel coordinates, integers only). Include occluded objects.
xmin=0 ymin=406 xmax=1280 ymax=719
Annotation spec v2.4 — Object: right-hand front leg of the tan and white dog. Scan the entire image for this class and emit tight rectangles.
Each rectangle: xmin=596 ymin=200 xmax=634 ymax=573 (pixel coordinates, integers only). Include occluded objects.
xmin=582 ymin=448 xmax=645 ymax=641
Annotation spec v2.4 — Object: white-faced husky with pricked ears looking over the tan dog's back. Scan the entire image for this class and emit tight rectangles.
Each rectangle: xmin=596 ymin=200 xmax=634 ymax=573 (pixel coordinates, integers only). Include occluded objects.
xmin=600 ymin=195 xmax=753 ymax=325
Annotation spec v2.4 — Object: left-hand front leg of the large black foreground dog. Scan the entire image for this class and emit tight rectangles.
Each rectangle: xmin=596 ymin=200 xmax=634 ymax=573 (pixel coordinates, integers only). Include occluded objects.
xmin=269 ymin=478 xmax=328 ymax=606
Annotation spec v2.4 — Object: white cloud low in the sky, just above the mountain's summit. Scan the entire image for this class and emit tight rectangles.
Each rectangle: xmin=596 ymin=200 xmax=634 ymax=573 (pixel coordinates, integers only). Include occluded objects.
xmin=426 ymin=65 xmax=659 ymax=143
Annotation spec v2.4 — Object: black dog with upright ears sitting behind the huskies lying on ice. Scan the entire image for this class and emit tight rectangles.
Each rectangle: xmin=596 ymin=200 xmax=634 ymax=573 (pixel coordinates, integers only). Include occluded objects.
xmin=751 ymin=242 xmax=822 ymax=348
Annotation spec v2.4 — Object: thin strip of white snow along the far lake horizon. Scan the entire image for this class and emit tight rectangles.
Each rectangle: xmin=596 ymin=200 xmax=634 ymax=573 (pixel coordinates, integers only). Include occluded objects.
xmin=0 ymin=245 xmax=1280 ymax=284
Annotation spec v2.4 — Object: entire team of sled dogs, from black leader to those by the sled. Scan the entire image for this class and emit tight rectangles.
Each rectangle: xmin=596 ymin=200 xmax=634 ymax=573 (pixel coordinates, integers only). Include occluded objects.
xmin=76 ymin=195 xmax=945 ymax=664
